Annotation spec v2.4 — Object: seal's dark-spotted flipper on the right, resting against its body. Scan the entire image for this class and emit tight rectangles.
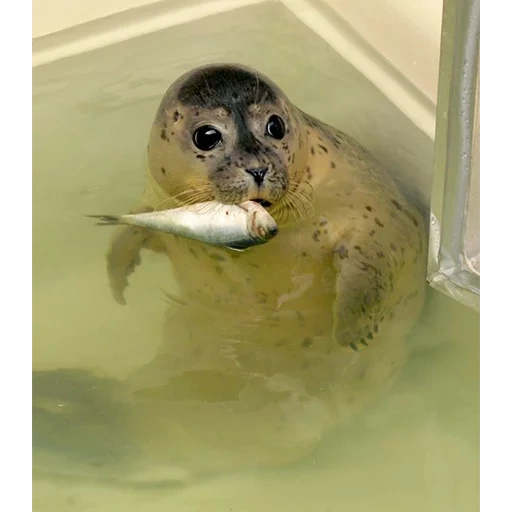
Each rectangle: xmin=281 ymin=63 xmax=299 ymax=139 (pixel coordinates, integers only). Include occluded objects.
xmin=333 ymin=240 xmax=393 ymax=350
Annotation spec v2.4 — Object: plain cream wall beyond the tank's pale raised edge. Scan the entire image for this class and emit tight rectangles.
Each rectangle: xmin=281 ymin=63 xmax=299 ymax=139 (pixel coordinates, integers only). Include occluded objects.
xmin=32 ymin=0 xmax=443 ymax=106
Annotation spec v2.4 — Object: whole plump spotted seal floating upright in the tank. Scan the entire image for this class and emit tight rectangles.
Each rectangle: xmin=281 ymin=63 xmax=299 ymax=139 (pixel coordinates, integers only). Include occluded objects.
xmin=32 ymin=64 xmax=427 ymax=480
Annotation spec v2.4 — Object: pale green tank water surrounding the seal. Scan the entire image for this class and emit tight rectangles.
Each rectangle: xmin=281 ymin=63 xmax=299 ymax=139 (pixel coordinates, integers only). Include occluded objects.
xmin=33 ymin=5 xmax=480 ymax=512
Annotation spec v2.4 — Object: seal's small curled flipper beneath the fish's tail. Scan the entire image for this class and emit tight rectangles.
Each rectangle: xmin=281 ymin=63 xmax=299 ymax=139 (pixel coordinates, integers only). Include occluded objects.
xmin=106 ymin=206 xmax=163 ymax=305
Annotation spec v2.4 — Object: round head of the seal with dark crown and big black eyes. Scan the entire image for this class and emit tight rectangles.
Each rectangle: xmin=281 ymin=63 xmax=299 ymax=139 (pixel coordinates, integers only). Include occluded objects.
xmin=148 ymin=64 xmax=307 ymax=216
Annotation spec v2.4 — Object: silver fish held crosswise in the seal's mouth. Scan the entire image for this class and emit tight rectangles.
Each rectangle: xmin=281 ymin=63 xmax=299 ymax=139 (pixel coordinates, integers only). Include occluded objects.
xmin=88 ymin=201 xmax=279 ymax=251
